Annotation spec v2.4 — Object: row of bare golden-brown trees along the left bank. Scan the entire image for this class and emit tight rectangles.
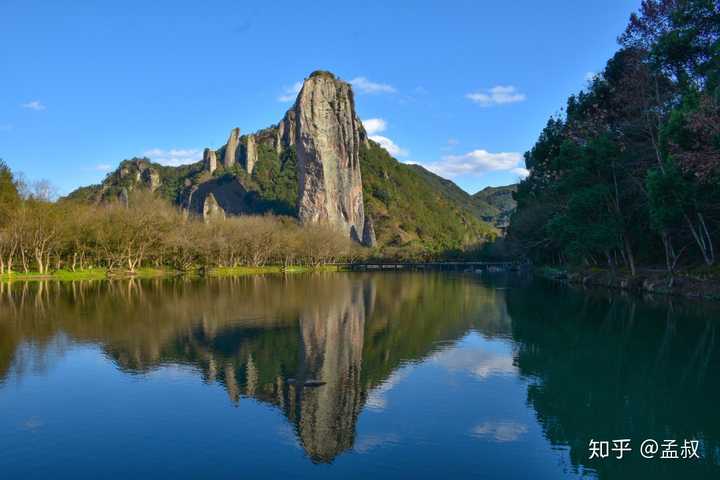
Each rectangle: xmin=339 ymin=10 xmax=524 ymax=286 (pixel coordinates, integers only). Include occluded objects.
xmin=0 ymin=160 xmax=358 ymax=275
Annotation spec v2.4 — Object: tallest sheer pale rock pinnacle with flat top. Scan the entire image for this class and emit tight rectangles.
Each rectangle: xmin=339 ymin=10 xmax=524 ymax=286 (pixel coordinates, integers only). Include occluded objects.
xmin=286 ymin=72 xmax=367 ymax=242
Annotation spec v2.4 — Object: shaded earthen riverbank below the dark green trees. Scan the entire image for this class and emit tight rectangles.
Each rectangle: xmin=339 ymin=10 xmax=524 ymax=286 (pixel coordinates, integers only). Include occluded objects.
xmin=534 ymin=266 xmax=720 ymax=301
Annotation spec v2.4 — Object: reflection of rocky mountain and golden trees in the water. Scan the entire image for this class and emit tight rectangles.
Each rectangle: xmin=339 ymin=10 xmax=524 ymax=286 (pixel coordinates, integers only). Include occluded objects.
xmin=0 ymin=274 xmax=511 ymax=463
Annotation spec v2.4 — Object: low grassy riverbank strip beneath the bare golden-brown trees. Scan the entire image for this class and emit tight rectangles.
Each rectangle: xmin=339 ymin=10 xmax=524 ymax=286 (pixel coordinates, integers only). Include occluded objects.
xmin=0 ymin=265 xmax=344 ymax=282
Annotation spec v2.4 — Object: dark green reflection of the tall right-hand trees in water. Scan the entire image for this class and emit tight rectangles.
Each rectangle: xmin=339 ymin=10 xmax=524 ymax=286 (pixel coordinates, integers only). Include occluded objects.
xmin=507 ymin=283 xmax=720 ymax=478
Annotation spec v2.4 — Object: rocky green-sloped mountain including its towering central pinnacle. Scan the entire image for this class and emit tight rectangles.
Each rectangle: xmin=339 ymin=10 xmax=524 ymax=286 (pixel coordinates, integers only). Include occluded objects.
xmin=69 ymin=71 xmax=497 ymax=252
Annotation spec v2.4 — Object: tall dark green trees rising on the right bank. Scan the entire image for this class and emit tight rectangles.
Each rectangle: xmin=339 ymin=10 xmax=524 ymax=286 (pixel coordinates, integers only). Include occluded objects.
xmin=509 ymin=0 xmax=720 ymax=279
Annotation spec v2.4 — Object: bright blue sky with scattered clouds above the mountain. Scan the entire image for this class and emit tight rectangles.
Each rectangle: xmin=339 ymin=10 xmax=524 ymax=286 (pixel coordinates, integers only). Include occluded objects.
xmin=0 ymin=0 xmax=639 ymax=194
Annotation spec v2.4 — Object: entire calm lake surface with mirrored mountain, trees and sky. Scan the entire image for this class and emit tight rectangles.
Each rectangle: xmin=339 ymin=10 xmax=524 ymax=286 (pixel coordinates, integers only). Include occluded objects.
xmin=0 ymin=273 xmax=720 ymax=480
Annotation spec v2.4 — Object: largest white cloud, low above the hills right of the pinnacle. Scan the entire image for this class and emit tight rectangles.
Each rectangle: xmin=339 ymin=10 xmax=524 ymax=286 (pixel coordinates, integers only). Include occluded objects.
xmin=426 ymin=150 xmax=525 ymax=177
